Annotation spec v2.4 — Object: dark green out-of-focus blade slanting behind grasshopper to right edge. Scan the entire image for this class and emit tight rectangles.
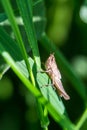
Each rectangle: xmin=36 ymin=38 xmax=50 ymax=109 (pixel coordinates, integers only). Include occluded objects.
xmin=40 ymin=33 xmax=87 ymax=103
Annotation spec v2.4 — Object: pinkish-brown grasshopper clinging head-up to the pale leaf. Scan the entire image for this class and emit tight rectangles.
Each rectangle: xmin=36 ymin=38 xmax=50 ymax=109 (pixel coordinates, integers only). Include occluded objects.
xmin=45 ymin=54 xmax=70 ymax=100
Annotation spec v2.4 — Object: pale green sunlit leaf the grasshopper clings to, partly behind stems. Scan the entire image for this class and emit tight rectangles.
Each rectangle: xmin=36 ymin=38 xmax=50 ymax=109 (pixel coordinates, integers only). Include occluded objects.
xmin=17 ymin=55 xmax=65 ymax=114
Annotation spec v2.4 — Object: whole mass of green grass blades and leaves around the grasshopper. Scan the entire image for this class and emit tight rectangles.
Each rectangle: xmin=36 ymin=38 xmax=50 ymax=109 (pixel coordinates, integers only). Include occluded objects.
xmin=0 ymin=0 xmax=87 ymax=130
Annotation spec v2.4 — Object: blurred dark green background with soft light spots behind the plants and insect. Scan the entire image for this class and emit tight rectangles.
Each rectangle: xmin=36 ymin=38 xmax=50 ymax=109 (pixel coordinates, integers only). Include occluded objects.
xmin=0 ymin=0 xmax=87 ymax=130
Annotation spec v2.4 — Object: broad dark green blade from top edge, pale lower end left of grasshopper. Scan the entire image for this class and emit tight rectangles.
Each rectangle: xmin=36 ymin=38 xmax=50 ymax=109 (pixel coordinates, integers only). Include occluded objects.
xmin=17 ymin=0 xmax=41 ymax=67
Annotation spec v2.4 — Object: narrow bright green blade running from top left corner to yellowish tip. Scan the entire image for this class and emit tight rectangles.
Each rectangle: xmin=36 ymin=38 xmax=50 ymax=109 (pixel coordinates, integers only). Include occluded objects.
xmin=1 ymin=0 xmax=35 ymax=85
